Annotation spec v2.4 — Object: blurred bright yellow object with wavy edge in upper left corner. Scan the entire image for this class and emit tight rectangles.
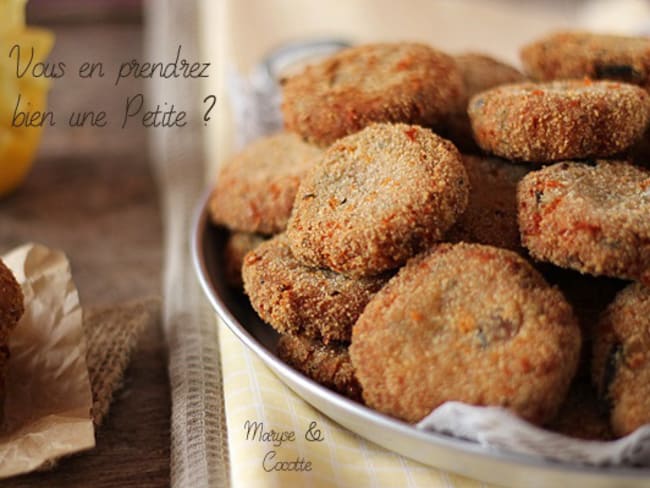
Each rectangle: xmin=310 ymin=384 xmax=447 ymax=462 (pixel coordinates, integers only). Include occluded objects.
xmin=0 ymin=0 xmax=54 ymax=197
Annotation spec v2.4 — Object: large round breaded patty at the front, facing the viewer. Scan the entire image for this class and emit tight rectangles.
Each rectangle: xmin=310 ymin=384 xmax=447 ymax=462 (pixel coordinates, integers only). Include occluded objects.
xmin=350 ymin=243 xmax=580 ymax=424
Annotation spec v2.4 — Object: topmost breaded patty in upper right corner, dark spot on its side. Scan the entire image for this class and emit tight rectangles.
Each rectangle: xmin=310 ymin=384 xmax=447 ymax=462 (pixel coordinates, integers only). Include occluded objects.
xmin=521 ymin=31 xmax=650 ymax=90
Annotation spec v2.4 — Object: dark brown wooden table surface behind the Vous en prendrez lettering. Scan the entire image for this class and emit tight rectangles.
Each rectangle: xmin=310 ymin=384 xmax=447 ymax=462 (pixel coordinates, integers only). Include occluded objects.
xmin=0 ymin=19 xmax=170 ymax=487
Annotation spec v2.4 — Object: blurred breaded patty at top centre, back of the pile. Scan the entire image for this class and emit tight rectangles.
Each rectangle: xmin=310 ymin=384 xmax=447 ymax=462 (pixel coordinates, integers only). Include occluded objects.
xmin=282 ymin=43 xmax=463 ymax=146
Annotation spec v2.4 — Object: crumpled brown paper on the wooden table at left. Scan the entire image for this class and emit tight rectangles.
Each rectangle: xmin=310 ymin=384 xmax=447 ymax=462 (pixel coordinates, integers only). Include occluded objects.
xmin=0 ymin=244 xmax=95 ymax=478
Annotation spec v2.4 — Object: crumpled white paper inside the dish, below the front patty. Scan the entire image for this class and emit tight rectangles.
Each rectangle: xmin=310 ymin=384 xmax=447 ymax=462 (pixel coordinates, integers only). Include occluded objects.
xmin=417 ymin=402 xmax=650 ymax=466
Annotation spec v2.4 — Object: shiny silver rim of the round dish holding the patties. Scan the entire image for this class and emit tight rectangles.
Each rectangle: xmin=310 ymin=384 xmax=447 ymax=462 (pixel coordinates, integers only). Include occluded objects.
xmin=192 ymin=196 xmax=650 ymax=488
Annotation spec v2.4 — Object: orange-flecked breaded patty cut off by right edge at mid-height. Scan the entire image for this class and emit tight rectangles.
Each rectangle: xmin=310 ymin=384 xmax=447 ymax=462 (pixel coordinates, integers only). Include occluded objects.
xmin=517 ymin=160 xmax=650 ymax=283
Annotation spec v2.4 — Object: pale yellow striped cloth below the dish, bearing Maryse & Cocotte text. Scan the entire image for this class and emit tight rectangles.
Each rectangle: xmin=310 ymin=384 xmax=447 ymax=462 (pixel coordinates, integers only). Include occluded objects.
xmin=219 ymin=321 xmax=494 ymax=488
